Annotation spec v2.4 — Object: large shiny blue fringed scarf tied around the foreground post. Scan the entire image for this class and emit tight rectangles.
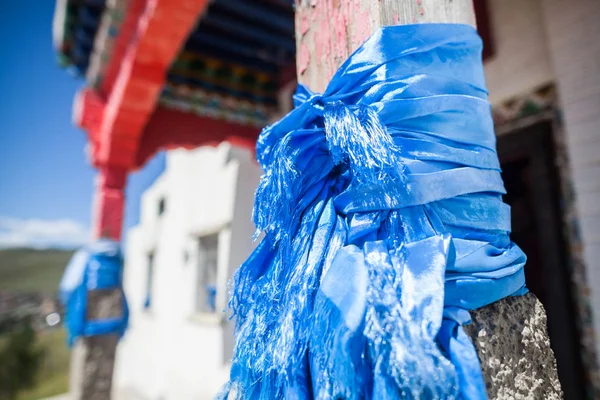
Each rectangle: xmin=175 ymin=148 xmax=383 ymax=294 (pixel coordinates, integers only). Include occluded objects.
xmin=220 ymin=24 xmax=527 ymax=400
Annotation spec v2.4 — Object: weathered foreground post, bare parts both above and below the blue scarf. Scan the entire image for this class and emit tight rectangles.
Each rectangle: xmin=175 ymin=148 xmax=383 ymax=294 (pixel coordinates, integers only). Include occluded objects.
xmin=296 ymin=0 xmax=562 ymax=399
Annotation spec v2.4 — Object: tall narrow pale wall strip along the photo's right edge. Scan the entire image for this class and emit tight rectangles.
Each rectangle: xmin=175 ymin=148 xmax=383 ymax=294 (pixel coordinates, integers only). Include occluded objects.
xmin=543 ymin=0 xmax=600 ymax=356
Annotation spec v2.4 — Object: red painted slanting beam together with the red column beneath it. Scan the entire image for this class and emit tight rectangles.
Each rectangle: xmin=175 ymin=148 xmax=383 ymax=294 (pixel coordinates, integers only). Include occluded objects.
xmin=74 ymin=0 xmax=209 ymax=240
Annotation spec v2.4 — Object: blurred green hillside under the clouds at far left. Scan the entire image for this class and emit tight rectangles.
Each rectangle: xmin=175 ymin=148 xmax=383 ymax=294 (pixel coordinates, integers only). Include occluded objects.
xmin=0 ymin=249 xmax=73 ymax=294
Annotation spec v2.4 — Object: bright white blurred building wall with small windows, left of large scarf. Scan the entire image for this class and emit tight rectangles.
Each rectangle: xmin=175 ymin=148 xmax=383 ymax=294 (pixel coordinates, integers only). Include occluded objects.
xmin=114 ymin=144 xmax=260 ymax=400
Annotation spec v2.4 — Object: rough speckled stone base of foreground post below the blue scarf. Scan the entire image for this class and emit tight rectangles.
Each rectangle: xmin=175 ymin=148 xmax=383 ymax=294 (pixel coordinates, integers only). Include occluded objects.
xmin=465 ymin=293 xmax=563 ymax=400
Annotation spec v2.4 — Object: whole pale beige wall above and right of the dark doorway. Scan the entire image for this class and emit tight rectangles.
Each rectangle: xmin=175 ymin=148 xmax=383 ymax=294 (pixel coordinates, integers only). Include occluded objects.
xmin=484 ymin=0 xmax=600 ymax=366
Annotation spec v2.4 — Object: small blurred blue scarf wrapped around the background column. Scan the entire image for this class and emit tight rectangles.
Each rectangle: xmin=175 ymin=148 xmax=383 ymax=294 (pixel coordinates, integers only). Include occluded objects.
xmin=59 ymin=240 xmax=129 ymax=345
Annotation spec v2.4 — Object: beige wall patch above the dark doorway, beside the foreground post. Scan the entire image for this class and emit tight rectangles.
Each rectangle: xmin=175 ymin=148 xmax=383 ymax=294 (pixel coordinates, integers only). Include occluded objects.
xmin=484 ymin=0 xmax=554 ymax=104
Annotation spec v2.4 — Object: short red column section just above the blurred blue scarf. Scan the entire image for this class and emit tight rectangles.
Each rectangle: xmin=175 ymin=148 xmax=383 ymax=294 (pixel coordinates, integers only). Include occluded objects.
xmin=93 ymin=166 xmax=128 ymax=240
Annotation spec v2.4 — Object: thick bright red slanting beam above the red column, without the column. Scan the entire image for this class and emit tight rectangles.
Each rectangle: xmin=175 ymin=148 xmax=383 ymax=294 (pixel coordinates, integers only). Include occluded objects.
xmin=97 ymin=0 xmax=209 ymax=167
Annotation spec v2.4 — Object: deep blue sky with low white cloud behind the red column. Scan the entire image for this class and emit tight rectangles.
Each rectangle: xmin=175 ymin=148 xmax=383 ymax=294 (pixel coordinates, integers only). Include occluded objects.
xmin=0 ymin=0 xmax=164 ymax=247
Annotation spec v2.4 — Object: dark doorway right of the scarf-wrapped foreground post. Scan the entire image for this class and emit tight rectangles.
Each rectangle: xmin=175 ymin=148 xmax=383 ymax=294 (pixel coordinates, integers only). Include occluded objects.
xmin=498 ymin=122 xmax=585 ymax=400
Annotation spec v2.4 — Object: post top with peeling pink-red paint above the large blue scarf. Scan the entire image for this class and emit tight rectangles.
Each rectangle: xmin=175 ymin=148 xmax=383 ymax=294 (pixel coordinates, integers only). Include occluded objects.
xmin=296 ymin=0 xmax=475 ymax=92
